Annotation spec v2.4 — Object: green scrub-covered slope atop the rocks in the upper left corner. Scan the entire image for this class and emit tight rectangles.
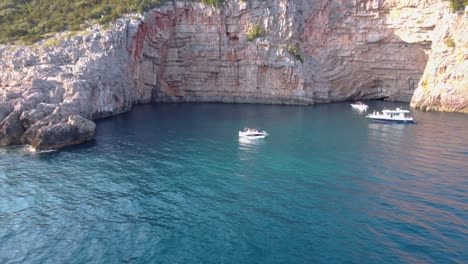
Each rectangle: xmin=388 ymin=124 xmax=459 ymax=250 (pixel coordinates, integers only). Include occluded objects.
xmin=0 ymin=0 xmax=167 ymax=44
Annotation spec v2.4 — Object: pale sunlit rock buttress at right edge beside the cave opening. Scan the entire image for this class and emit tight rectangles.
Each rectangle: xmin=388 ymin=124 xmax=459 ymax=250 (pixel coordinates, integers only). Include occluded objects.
xmin=411 ymin=12 xmax=468 ymax=113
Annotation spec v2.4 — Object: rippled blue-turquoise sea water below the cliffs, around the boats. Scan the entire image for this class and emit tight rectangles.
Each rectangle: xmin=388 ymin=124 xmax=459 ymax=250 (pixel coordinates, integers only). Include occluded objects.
xmin=0 ymin=102 xmax=468 ymax=263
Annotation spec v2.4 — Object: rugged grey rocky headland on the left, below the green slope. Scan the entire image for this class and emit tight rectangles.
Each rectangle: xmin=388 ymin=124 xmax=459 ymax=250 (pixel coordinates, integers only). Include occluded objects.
xmin=0 ymin=18 xmax=141 ymax=149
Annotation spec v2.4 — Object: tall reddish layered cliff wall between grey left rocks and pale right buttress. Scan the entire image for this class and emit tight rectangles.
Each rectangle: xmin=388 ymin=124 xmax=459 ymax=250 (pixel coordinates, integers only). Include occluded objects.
xmin=132 ymin=0 xmax=438 ymax=104
